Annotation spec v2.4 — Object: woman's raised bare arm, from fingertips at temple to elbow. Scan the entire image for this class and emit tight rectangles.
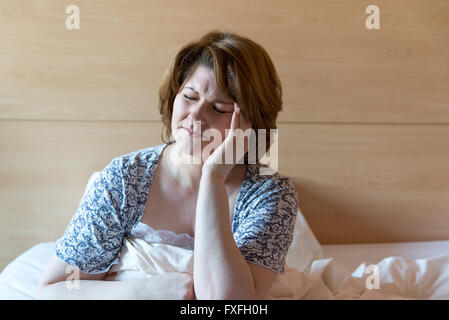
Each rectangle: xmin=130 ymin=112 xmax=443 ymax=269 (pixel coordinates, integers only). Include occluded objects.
xmin=193 ymin=103 xmax=276 ymax=300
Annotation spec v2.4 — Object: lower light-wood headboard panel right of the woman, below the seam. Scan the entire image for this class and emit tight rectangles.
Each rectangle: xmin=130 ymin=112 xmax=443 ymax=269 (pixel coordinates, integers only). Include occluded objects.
xmin=279 ymin=125 xmax=449 ymax=244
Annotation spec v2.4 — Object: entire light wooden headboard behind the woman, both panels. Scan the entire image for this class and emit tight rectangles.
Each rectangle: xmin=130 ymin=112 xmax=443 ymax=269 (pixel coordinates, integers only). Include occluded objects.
xmin=0 ymin=0 xmax=449 ymax=269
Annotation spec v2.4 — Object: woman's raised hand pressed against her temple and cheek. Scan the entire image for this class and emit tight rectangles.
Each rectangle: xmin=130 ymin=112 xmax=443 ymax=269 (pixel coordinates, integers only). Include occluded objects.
xmin=203 ymin=103 xmax=251 ymax=179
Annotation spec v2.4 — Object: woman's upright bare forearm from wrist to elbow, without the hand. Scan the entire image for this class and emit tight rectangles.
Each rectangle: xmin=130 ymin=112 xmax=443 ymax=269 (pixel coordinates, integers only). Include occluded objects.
xmin=193 ymin=170 xmax=256 ymax=299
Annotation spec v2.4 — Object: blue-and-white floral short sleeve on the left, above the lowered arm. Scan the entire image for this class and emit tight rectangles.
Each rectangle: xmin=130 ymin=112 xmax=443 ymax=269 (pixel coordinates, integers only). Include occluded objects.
xmin=55 ymin=158 xmax=126 ymax=273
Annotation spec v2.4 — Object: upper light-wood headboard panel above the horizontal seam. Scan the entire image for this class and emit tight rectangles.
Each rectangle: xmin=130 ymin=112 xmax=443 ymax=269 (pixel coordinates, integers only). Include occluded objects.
xmin=0 ymin=0 xmax=449 ymax=123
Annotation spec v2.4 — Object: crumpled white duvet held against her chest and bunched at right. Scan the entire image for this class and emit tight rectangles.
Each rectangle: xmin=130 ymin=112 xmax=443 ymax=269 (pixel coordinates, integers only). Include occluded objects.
xmin=110 ymin=238 xmax=449 ymax=300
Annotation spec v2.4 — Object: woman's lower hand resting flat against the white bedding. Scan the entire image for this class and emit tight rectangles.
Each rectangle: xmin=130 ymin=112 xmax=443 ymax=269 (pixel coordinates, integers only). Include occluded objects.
xmin=139 ymin=272 xmax=196 ymax=300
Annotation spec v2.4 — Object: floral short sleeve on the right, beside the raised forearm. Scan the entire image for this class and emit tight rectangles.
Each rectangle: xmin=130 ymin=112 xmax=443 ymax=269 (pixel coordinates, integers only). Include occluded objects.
xmin=234 ymin=176 xmax=299 ymax=274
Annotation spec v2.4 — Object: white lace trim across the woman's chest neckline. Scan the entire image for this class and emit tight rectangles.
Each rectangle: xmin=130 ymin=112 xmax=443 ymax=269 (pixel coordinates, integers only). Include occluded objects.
xmin=132 ymin=222 xmax=195 ymax=250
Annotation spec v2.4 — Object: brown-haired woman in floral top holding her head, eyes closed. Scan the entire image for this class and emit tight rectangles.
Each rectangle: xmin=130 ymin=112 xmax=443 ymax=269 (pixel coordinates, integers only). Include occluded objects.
xmin=40 ymin=32 xmax=298 ymax=299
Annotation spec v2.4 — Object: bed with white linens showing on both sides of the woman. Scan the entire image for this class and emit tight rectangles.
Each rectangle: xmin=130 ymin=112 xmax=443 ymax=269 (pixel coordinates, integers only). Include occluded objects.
xmin=0 ymin=211 xmax=449 ymax=300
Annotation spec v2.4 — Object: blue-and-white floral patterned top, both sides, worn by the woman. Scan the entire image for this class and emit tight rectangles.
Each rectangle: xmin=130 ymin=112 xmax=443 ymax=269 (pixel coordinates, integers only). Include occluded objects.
xmin=55 ymin=142 xmax=299 ymax=273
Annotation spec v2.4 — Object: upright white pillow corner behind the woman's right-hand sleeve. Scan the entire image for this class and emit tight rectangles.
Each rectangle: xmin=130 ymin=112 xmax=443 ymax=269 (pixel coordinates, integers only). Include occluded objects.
xmin=286 ymin=209 xmax=323 ymax=272
